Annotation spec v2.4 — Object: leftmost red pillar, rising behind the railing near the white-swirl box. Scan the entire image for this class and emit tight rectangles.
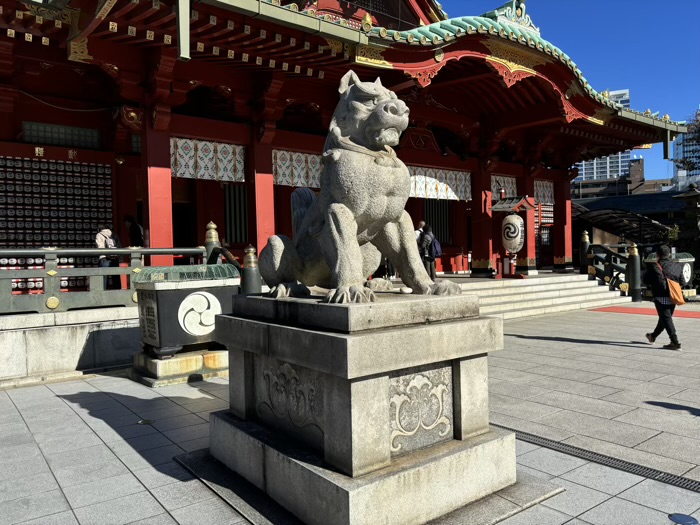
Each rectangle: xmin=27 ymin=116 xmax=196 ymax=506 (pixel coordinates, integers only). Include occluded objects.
xmin=144 ymin=126 xmax=173 ymax=266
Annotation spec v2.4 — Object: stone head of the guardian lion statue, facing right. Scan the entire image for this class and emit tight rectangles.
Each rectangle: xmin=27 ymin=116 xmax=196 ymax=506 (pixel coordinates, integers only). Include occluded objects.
xmin=326 ymin=71 xmax=408 ymax=151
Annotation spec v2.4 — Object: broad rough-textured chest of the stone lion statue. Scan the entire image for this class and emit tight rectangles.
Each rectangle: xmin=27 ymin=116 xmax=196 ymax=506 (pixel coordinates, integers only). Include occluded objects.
xmin=324 ymin=152 xmax=411 ymax=222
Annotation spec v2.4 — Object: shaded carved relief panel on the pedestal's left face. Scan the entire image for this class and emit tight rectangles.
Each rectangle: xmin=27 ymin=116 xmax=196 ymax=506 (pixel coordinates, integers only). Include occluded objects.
xmin=255 ymin=356 xmax=323 ymax=447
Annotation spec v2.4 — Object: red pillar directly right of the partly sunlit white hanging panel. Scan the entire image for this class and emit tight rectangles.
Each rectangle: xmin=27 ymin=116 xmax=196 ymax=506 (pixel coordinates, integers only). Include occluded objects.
xmin=472 ymin=173 xmax=495 ymax=276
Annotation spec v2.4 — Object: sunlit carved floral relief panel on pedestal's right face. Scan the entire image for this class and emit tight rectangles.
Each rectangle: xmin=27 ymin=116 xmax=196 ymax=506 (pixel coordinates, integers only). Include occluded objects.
xmin=389 ymin=365 xmax=453 ymax=455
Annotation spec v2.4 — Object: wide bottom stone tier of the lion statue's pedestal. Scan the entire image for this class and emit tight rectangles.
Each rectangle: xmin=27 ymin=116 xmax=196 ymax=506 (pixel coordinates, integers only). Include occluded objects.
xmin=210 ymin=412 xmax=516 ymax=525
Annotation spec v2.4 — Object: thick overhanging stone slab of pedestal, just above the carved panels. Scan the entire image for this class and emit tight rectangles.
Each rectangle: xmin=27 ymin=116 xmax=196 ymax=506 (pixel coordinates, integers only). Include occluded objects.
xmin=221 ymin=316 xmax=503 ymax=379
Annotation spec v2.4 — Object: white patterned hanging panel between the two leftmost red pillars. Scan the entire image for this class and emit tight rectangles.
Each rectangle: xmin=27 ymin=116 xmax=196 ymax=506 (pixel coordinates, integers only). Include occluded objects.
xmin=170 ymin=137 xmax=245 ymax=182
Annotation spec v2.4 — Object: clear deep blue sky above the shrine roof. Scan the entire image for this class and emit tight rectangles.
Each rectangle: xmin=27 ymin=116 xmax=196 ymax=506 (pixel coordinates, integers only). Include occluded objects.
xmin=441 ymin=0 xmax=700 ymax=179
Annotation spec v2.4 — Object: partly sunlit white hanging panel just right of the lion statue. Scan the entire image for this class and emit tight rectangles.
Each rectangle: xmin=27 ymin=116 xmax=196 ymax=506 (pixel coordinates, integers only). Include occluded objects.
xmin=408 ymin=166 xmax=472 ymax=201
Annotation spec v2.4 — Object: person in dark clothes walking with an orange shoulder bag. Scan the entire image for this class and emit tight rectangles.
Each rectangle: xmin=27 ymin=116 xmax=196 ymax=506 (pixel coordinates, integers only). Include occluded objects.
xmin=643 ymin=245 xmax=686 ymax=350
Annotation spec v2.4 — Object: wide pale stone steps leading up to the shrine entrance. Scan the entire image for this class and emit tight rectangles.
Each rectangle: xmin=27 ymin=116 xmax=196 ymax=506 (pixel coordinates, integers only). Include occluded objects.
xmin=460 ymin=274 xmax=632 ymax=319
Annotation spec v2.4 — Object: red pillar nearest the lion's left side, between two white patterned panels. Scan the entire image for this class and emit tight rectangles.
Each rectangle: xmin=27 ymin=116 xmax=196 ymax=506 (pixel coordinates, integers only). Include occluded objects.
xmin=246 ymin=141 xmax=275 ymax=254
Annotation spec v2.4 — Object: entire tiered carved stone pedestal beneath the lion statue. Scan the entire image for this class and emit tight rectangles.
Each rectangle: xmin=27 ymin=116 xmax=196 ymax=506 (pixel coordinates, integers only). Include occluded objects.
xmin=210 ymin=294 xmax=515 ymax=525
